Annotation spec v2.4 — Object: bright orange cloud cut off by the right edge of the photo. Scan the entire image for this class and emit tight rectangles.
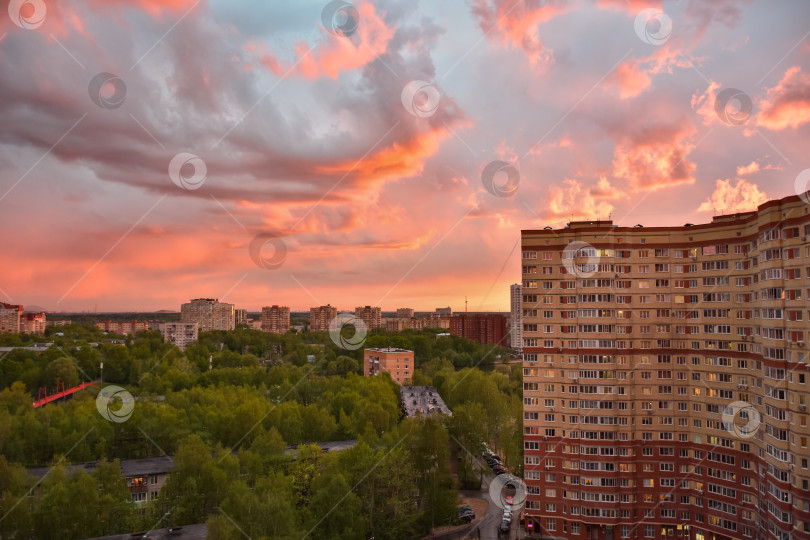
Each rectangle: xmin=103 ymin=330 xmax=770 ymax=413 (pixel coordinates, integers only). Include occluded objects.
xmin=756 ymin=66 xmax=810 ymax=130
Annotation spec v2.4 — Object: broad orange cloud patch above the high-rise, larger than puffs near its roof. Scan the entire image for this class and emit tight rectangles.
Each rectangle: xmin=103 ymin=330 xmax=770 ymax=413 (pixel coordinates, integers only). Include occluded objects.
xmin=613 ymin=124 xmax=695 ymax=190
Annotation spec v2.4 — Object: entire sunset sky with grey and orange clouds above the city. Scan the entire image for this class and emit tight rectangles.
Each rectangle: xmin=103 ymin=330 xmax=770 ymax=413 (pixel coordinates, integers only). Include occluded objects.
xmin=0 ymin=0 xmax=810 ymax=311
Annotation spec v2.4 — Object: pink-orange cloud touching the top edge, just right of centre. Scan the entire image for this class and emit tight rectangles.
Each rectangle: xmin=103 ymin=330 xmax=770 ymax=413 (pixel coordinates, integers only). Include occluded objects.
xmin=472 ymin=0 xmax=570 ymax=65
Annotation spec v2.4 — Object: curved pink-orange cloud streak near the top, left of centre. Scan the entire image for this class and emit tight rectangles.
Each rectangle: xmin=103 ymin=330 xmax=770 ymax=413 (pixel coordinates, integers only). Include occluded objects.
xmin=252 ymin=3 xmax=394 ymax=79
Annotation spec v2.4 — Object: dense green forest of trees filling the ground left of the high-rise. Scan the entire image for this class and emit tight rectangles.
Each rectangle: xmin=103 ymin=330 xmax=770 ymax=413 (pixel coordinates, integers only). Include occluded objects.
xmin=0 ymin=324 xmax=522 ymax=540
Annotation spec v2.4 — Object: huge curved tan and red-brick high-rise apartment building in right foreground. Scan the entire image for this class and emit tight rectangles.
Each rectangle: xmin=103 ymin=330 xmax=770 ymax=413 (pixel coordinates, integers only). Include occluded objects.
xmin=521 ymin=196 xmax=810 ymax=540
